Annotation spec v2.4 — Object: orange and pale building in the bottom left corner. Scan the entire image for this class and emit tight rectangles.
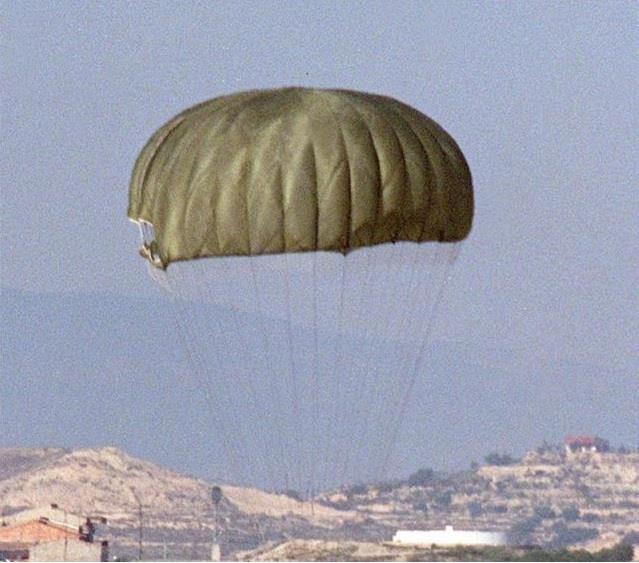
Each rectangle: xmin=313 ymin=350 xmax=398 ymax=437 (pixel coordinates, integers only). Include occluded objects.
xmin=0 ymin=504 xmax=109 ymax=561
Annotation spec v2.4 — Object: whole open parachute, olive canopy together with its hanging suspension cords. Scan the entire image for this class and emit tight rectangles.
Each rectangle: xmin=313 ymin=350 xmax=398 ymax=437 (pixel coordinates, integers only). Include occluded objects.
xmin=128 ymin=88 xmax=473 ymax=495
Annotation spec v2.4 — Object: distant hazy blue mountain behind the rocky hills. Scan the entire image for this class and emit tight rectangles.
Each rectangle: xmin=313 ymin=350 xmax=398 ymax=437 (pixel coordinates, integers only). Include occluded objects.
xmin=0 ymin=288 xmax=639 ymax=486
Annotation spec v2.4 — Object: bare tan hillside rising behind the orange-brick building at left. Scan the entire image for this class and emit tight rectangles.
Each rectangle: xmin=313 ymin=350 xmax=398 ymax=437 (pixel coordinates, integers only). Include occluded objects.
xmin=0 ymin=448 xmax=376 ymax=559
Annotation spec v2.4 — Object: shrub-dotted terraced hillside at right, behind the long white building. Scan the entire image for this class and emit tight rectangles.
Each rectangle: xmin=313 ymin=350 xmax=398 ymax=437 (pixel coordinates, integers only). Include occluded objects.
xmin=324 ymin=448 xmax=639 ymax=549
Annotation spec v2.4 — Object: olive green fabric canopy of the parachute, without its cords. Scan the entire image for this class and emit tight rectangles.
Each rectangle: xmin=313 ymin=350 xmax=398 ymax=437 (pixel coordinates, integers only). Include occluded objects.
xmin=128 ymin=88 xmax=473 ymax=267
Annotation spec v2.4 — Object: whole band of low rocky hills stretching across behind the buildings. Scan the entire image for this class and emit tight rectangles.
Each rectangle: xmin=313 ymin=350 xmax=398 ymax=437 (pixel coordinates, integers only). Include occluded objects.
xmin=0 ymin=448 xmax=639 ymax=559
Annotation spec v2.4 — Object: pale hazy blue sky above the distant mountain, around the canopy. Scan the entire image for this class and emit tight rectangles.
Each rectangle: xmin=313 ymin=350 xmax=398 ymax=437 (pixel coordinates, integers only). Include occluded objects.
xmin=0 ymin=1 xmax=639 ymax=482
